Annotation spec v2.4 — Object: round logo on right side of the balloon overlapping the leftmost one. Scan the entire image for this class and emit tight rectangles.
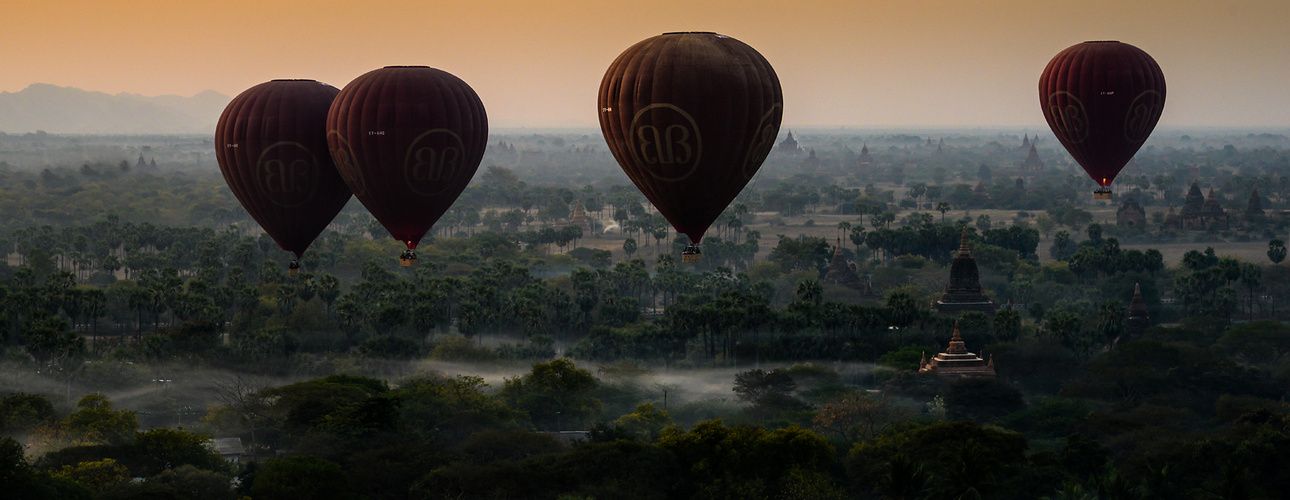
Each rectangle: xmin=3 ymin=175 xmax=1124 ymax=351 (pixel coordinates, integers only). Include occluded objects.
xmin=404 ymin=129 xmax=466 ymax=196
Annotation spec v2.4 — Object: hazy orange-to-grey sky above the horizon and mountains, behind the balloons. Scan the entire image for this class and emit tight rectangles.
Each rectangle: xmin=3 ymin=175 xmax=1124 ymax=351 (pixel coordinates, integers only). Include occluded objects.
xmin=0 ymin=0 xmax=1290 ymax=129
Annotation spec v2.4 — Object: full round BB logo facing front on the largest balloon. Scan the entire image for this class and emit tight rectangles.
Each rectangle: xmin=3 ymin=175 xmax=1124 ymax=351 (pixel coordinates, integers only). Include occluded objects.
xmin=627 ymin=103 xmax=703 ymax=182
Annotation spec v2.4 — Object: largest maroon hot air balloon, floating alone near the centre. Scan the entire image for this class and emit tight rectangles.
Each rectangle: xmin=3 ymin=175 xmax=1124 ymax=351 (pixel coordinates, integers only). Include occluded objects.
xmin=597 ymin=32 xmax=784 ymax=262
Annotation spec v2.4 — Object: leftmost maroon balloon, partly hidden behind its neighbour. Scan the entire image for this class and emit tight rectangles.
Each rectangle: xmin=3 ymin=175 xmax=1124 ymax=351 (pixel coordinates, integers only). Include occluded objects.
xmin=215 ymin=80 xmax=350 ymax=274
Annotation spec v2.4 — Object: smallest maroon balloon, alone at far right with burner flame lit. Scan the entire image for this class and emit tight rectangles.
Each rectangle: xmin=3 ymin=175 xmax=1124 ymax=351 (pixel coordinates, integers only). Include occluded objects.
xmin=1040 ymin=41 xmax=1165 ymax=198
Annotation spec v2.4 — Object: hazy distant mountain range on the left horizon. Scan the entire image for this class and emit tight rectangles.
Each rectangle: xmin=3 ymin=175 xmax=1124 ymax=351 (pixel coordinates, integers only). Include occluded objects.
xmin=0 ymin=84 xmax=232 ymax=135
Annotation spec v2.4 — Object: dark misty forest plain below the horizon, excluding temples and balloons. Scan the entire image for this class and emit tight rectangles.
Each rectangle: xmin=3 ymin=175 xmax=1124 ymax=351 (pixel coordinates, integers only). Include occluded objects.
xmin=0 ymin=131 xmax=1290 ymax=499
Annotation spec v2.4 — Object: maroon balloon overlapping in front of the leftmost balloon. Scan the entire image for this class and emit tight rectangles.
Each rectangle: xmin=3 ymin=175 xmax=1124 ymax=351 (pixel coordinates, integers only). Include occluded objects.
xmin=326 ymin=66 xmax=488 ymax=265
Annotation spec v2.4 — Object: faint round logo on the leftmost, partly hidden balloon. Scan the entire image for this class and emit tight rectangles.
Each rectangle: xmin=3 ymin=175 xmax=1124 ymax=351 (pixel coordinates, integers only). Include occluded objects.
xmin=255 ymin=140 xmax=319 ymax=207
